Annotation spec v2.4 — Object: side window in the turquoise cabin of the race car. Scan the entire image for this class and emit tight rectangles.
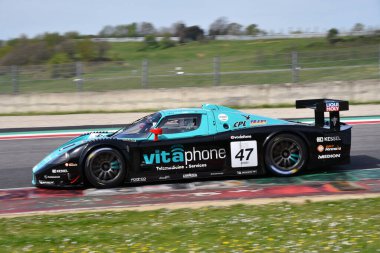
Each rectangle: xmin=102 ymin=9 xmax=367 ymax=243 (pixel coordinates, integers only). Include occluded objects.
xmin=158 ymin=114 xmax=201 ymax=134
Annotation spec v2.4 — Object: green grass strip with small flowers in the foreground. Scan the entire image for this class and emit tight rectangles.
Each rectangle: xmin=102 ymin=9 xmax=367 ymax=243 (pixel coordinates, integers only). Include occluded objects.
xmin=0 ymin=198 xmax=380 ymax=253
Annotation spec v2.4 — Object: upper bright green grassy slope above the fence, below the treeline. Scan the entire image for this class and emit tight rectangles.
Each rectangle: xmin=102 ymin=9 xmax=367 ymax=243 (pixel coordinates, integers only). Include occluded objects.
xmin=109 ymin=38 xmax=380 ymax=61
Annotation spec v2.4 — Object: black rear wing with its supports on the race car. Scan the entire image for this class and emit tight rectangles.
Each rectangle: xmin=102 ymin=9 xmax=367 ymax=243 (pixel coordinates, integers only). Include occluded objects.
xmin=296 ymin=98 xmax=349 ymax=131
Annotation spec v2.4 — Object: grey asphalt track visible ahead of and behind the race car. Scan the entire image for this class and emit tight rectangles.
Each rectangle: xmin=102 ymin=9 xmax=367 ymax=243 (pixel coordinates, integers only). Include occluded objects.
xmin=0 ymin=124 xmax=380 ymax=189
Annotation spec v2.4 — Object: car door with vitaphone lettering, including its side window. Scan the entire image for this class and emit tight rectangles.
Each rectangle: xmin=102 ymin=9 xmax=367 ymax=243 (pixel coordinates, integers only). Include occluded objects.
xmin=139 ymin=113 xmax=227 ymax=179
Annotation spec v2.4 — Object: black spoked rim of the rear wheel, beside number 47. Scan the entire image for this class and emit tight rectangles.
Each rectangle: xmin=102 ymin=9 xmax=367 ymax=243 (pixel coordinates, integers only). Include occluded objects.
xmin=271 ymin=139 xmax=303 ymax=172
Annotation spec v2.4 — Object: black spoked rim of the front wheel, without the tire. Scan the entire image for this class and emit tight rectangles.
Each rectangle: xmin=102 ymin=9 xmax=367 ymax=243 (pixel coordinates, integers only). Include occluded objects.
xmin=89 ymin=150 xmax=123 ymax=184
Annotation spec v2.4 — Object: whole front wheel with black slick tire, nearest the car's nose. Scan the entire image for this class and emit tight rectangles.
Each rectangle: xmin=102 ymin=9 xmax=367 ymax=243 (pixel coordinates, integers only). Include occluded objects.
xmin=84 ymin=147 xmax=127 ymax=188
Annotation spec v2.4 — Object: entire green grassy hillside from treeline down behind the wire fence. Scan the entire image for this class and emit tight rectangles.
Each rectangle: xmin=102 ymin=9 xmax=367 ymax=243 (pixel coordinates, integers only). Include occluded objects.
xmin=0 ymin=36 xmax=380 ymax=94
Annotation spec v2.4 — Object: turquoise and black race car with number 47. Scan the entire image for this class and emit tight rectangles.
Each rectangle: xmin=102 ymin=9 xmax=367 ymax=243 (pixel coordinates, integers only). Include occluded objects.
xmin=33 ymin=99 xmax=351 ymax=188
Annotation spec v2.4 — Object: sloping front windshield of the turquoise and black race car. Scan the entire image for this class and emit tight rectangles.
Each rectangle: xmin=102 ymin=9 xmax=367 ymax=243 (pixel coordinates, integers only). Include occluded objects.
xmin=114 ymin=112 xmax=161 ymax=138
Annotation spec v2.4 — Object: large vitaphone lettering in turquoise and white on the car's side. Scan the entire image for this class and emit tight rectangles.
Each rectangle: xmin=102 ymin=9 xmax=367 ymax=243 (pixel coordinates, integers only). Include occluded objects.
xmin=143 ymin=145 xmax=226 ymax=165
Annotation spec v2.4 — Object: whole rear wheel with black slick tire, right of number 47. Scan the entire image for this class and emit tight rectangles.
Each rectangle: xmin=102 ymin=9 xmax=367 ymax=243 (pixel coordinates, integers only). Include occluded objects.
xmin=265 ymin=134 xmax=307 ymax=176
